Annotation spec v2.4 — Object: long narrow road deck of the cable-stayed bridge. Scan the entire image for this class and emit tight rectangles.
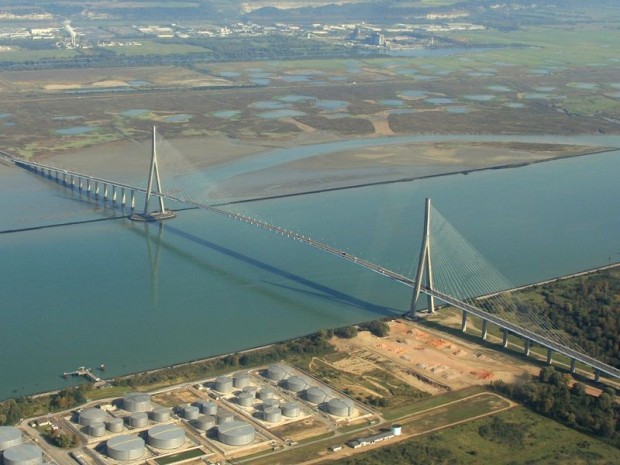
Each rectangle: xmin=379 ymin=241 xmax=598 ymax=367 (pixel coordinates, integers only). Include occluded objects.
xmin=14 ymin=158 xmax=620 ymax=379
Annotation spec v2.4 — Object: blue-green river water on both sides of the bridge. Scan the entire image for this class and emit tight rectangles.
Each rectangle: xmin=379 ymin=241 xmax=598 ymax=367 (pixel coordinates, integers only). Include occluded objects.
xmin=0 ymin=136 xmax=620 ymax=398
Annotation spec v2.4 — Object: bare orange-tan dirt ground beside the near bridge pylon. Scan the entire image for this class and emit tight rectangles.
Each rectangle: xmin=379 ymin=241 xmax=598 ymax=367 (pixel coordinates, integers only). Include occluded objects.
xmin=333 ymin=319 xmax=538 ymax=394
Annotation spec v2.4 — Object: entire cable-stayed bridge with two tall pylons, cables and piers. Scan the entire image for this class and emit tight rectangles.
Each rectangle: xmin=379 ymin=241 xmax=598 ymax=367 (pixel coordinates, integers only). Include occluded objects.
xmin=7 ymin=131 xmax=620 ymax=381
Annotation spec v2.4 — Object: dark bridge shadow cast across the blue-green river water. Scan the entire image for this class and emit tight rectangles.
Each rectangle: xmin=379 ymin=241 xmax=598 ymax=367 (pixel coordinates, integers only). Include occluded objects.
xmin=165 ymin=225 xmax=402 ymax=316
